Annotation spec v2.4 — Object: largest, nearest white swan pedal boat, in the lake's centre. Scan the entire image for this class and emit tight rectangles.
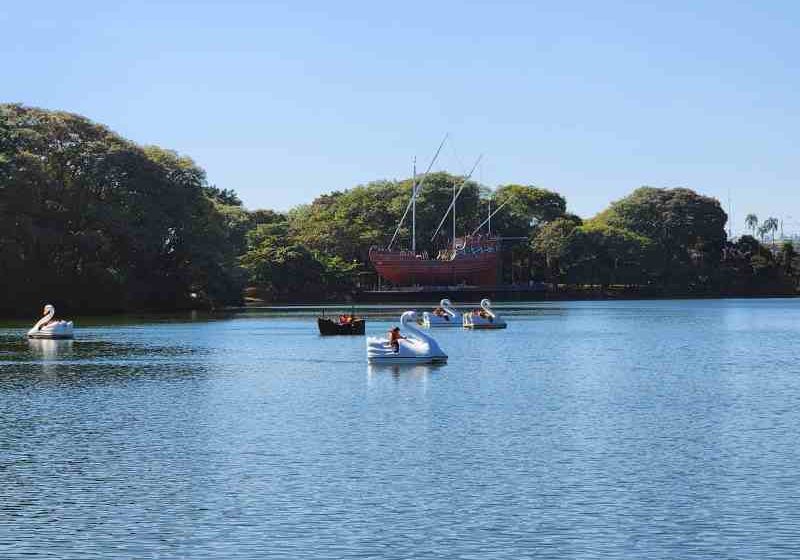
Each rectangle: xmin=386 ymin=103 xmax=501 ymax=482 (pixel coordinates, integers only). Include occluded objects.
xmin=367 ymin=311 xmax=447 ymax=364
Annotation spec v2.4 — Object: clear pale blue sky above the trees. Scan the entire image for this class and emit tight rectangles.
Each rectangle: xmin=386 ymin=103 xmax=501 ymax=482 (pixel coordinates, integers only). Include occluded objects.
xmin=6 ymin=0 xmax=800 ymax=233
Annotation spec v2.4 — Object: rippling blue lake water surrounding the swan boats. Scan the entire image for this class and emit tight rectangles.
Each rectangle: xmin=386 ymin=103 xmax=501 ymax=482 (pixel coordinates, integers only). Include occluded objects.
xmin=0 ymin=300 xmax=800 ymax=559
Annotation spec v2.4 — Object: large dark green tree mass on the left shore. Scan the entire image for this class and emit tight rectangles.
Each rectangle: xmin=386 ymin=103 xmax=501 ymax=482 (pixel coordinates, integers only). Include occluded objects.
xmin=0 ymin=105 xmax=241 ymax=312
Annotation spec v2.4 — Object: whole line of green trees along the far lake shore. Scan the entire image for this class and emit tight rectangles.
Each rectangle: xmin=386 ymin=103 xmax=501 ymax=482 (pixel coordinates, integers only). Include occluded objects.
xmin=0 ymin=104 xmax=800 ymax=313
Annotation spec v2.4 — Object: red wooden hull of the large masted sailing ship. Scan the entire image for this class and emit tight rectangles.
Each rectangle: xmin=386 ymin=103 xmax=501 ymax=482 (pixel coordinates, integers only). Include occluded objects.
xmin=370 ymin=251 xmax=498 ymax=286
